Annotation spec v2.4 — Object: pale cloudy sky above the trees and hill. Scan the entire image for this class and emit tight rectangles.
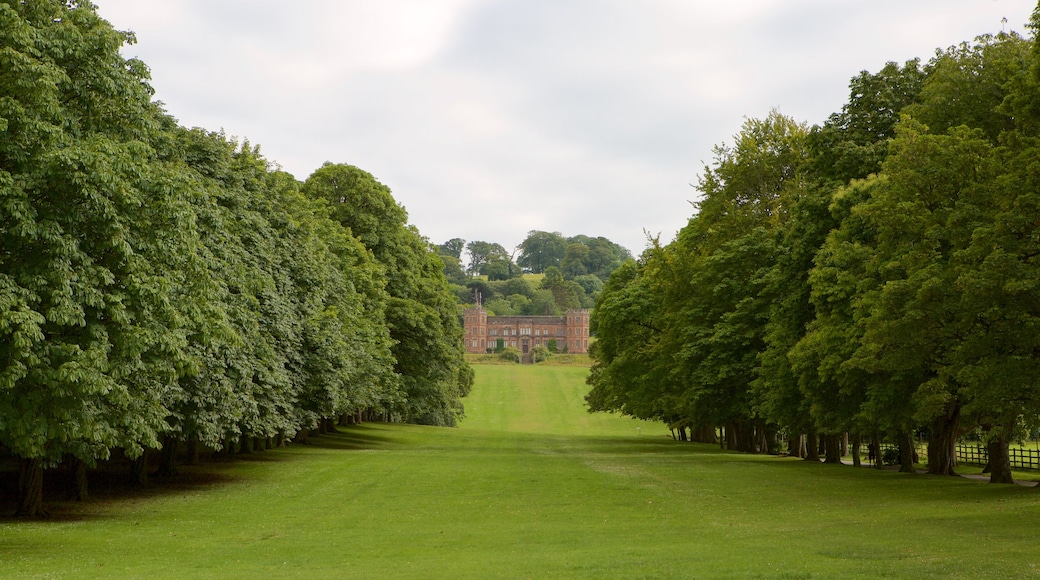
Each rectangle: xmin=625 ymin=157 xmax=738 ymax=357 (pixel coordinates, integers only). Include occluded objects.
xmin=95 ymin=0 xmax=1037 ymax=255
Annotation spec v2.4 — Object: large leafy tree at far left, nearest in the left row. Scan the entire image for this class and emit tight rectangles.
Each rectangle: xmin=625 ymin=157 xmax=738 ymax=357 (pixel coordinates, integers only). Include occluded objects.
xmin=0 ymin=1 xmax=193 ymax=517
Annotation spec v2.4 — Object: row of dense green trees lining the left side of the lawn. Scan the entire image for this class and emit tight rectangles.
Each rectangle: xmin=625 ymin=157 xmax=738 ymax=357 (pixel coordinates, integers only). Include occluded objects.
xmin=0 ymin=0 xmax=472 ymax=517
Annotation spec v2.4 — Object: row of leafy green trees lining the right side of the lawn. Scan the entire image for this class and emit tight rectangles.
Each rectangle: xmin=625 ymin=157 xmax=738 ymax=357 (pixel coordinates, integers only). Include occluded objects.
xmin=587 ymin=14 xmax=1040 ymax=482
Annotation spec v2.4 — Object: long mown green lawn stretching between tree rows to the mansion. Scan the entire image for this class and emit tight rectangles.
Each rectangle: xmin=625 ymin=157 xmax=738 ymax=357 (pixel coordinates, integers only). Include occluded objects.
xmin=0 ymin=366 xmax=1040 ymax=578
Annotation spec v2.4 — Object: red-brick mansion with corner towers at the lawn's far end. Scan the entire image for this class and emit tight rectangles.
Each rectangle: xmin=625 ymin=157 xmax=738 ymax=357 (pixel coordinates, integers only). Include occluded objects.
xmin=463 ymin=307 xmax=589 ymax=354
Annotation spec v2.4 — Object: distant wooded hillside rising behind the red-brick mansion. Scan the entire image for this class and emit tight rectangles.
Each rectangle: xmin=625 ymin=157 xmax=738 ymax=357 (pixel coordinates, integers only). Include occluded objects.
xmin=438 ymin=230 xmax=632 ymax=316
